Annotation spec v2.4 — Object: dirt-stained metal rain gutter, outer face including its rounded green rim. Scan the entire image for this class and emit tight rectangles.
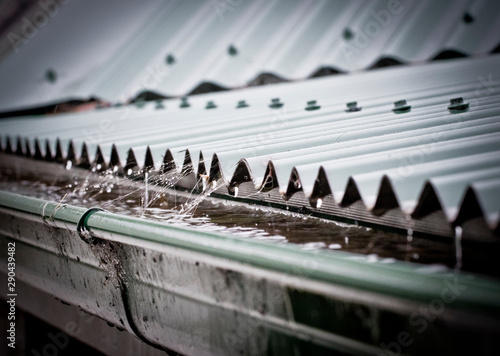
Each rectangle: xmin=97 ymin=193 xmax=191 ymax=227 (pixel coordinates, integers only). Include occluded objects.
xmin=0 ymin=192 xmax=500 ymax=355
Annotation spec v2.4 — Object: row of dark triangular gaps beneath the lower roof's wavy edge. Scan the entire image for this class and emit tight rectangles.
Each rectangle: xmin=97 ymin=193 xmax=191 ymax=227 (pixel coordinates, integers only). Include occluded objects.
xmin=1 ymin=136 xmax=500 ymax=240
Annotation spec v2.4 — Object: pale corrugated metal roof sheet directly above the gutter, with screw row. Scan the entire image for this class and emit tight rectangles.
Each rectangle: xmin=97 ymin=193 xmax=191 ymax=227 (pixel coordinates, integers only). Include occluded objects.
xmin=0 ymin=55 xmax=500 ymax=238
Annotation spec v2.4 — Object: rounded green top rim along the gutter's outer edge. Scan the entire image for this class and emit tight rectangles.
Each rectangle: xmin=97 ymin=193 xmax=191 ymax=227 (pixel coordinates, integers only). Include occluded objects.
xmin=0 ymin=191 xmax=500 ymax=316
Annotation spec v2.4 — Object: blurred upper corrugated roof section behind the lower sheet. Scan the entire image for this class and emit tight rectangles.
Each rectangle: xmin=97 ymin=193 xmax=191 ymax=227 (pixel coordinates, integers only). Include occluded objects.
xmin=0 ymin=0 xmax=500 ymax=111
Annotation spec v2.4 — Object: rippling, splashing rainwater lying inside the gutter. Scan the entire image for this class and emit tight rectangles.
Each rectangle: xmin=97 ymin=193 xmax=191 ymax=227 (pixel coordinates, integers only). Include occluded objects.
xmin=0 ymin=164 xmax=499 ymax=275
